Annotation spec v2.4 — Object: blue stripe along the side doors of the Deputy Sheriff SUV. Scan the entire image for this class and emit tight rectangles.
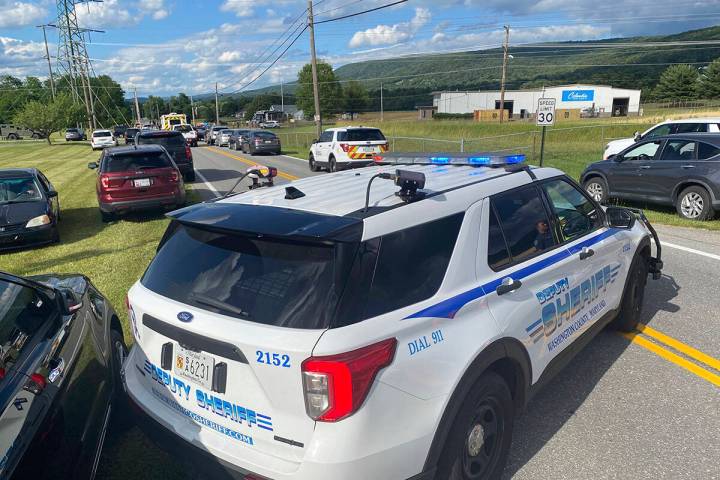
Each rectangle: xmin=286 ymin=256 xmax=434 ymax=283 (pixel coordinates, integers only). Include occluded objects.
xmin=403 ymin=228 xmax=617 ymax=320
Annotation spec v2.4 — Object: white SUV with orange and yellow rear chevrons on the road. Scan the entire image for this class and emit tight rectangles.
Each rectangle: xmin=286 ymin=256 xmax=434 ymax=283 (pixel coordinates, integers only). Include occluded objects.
xmin=308 ymin=127 xmax=388 ymax=172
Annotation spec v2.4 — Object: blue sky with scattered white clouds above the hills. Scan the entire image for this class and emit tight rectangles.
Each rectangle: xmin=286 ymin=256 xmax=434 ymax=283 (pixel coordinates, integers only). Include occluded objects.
xmin=0 ymin=0 xmax=720 ymax=95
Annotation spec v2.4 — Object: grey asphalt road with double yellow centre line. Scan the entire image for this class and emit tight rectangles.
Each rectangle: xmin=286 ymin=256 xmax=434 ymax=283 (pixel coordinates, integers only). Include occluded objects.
xmin=188 ymin=147 xmax=720 ymax=480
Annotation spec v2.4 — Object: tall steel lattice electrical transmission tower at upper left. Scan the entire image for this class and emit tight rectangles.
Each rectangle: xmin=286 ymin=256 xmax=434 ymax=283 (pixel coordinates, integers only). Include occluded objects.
xmin=50 ymin=0 xmax=102 ymax=130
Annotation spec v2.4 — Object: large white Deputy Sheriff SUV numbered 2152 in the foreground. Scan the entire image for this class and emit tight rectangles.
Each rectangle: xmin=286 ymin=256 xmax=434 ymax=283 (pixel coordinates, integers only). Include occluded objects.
xmin=123 ymin=154 xmax=662 ymax=480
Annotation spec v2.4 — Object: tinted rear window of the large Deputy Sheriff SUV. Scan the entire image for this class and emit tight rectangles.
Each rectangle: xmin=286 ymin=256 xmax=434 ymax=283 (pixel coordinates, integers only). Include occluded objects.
xmin=141 ymin=223 xmax=344 ymax=329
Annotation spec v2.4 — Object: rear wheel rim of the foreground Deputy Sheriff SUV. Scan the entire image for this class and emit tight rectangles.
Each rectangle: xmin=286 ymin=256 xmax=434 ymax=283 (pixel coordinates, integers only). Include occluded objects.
xmin=462 ymin=399 xmax=505 ymax=479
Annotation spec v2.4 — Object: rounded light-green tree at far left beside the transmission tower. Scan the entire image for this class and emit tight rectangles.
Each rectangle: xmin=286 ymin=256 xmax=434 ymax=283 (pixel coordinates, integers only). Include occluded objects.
xmin=14 ymin=93 xmax=83 ymax=145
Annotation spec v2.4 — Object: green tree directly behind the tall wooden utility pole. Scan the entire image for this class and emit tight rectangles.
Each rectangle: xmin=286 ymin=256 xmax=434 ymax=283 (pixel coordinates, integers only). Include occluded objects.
xmin=295 ymin=62 xmax=343 ymax=118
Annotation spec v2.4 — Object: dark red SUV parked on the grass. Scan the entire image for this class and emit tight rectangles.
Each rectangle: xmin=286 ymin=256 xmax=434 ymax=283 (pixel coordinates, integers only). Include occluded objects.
xmin=88 ymin=145 xmax=185 ymax=222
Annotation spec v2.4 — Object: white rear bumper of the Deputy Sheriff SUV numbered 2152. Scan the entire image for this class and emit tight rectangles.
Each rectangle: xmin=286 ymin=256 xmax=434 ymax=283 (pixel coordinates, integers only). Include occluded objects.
xmin=123 ymin=344 xmax=436 ymax=480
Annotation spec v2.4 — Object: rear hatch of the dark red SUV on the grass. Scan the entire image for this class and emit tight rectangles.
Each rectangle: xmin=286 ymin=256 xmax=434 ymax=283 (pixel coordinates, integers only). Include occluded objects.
xmin=99 ymin=150 xmax=180 ymax=201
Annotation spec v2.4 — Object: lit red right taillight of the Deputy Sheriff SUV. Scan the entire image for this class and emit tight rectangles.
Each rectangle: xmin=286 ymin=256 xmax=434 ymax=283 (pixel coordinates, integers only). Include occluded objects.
xmin=301 ymin=338 xmax=397 ymax=422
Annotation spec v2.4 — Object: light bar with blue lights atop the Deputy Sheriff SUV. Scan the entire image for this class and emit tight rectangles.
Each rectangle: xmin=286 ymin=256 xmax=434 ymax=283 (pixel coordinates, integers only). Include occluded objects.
xmin=374 ymin=152 xmax=525 ymax=167
